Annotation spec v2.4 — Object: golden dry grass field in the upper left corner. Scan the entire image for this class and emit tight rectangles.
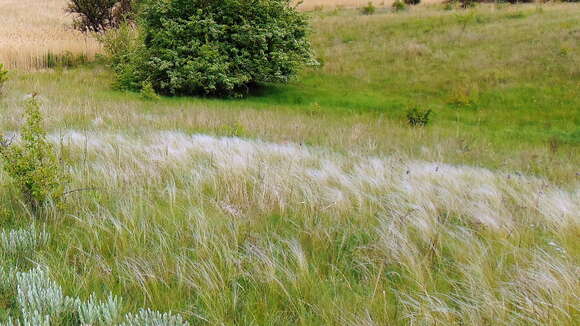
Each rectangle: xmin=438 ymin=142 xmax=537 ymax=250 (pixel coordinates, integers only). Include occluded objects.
xmin=0 ymin=0 xmax=99 ymax=70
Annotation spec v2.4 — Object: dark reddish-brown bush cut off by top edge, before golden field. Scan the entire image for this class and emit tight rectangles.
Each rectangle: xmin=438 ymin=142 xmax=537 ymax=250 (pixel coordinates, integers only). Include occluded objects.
xmin=67 ymin=0 xmax=135 ymax=33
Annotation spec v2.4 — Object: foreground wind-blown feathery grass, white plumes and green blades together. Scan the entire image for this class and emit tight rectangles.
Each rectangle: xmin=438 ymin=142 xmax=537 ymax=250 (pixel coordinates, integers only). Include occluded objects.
xmin=3 ymin=132 xmax=580 ymax=325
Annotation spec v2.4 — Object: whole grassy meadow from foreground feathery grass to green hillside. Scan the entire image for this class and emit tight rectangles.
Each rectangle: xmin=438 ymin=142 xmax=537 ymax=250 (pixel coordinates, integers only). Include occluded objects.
xmin=0 ymin=1 xmax=580 ymax=325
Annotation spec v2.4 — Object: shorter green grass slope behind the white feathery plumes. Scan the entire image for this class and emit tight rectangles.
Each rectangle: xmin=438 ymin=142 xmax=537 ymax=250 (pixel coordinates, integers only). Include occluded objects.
xmin=0 ymin=4 xmax=580 ymax=186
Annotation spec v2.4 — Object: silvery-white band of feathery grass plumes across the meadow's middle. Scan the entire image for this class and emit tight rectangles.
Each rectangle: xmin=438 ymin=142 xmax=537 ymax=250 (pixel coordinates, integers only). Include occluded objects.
xmin=57 ymin=132 xmax=580 ymax=232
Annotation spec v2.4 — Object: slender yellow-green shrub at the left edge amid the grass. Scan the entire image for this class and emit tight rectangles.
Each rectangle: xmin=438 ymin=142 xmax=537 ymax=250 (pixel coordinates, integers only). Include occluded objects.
xmin=0 ymin=96 xmax=66 ymax=212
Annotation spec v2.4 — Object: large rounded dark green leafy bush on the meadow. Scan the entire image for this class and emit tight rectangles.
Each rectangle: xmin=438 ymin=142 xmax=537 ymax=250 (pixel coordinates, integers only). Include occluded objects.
xmin=115 ymin=0 xmax=312 ymax=96
